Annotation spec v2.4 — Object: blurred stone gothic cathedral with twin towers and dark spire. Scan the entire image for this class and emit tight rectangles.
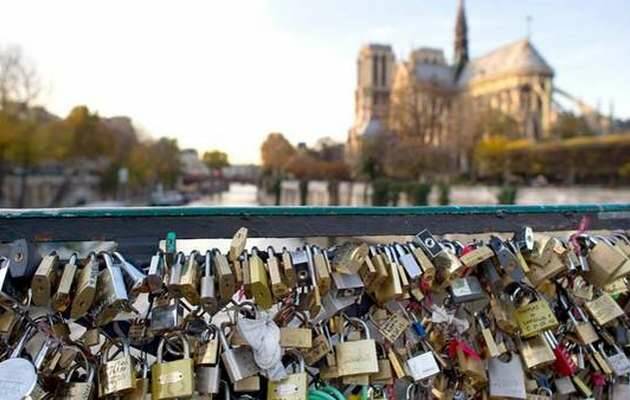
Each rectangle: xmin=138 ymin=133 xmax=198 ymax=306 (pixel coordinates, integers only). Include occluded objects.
xmin=346 ymin=0 xmax=554 ymax=170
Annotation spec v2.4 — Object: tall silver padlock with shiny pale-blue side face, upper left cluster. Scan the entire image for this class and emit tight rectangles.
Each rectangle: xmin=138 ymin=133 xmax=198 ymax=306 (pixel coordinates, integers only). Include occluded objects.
xmin=91 ymin=253 xmax=131 ymax=326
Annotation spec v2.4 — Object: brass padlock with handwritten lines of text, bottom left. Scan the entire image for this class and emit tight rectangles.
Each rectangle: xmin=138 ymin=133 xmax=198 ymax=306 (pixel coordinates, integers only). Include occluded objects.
xmin=98 ymin=338 xmax=136 ymax=396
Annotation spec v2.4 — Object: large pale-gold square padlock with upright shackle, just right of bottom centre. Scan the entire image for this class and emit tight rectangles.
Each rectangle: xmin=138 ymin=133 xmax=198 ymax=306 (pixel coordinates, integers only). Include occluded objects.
xmin=335 ymin=318 xmax=378 ymax=376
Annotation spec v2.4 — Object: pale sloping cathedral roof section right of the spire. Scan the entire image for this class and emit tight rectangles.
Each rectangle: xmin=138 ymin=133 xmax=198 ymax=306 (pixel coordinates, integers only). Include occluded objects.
xmin=458 ymin=39 xmax=553 ymax=86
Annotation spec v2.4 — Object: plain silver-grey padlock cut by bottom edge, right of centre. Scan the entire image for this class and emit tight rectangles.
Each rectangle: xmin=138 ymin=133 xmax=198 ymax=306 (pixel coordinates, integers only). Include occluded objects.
xmin=488 ymin=353 xmax=526 ymax=399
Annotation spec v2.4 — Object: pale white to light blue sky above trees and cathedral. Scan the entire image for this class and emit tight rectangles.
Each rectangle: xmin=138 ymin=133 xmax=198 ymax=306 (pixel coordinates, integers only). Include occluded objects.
xmin=0 ymin=0 xmax=630 ymax=163
